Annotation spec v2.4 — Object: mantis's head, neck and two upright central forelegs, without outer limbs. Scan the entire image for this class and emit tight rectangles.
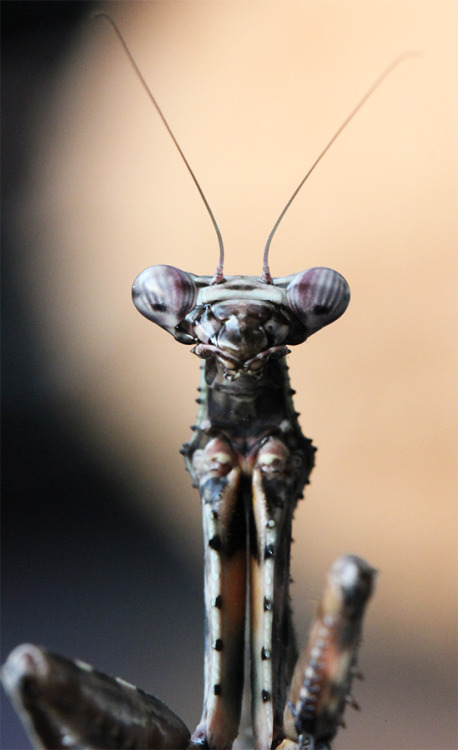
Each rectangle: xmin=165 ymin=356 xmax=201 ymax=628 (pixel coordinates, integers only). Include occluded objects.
xmin=133 ymin=266 xmax=350 ymax=748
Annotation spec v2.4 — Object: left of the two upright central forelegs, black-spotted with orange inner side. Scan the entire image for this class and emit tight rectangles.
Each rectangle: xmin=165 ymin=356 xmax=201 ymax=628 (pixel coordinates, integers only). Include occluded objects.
xmin=185 ymin=433 xmax=247 ymax=750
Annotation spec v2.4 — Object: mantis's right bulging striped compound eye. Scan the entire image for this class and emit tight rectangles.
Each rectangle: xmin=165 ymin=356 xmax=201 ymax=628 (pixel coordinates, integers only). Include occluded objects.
xmin=286 ymin=268 xmax=350 ymax=336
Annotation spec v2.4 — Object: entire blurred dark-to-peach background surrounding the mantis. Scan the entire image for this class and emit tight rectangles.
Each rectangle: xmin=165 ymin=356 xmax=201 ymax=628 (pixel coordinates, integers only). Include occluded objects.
xmin=1 ymin=0 xmax=458 ymax=750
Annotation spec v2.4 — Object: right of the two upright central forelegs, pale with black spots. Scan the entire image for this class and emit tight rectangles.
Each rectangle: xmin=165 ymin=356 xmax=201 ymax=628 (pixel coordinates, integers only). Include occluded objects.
xmin=250 ymin=437 xmax=314 ymax=750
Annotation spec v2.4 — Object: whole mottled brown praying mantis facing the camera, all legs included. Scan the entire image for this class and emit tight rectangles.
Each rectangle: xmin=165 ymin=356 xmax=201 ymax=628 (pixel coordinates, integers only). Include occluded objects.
xmin=6 ymin=16 xmax=424 ymax=748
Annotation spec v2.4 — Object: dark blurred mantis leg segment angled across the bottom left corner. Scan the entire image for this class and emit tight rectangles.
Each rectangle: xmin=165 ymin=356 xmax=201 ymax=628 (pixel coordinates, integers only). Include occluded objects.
xmin=2 ymin=644 xmax=190 ymax=750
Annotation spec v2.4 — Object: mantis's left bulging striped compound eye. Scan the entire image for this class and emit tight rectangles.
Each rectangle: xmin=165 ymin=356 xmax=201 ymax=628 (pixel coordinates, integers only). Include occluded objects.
xmin=132 ymin=266 xmax=197 ymax=335
